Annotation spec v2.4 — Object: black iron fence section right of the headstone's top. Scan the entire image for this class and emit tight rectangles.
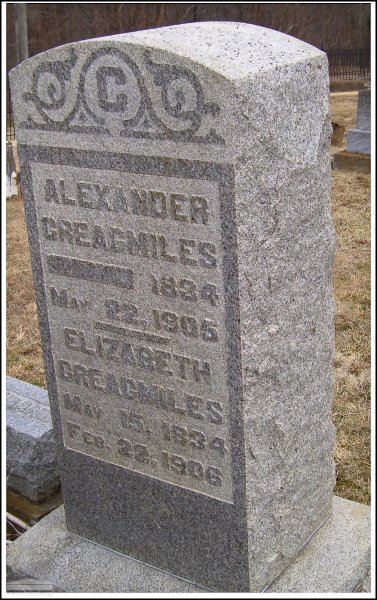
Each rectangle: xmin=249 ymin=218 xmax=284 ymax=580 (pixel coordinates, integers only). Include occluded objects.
xmin=327 ymin=48 xmax=370 ymax=79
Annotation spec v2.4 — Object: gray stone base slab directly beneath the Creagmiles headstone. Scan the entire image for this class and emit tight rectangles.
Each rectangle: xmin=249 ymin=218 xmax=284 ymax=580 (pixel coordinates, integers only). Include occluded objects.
xmin=7 ymin=496 xmax=371 ymax=593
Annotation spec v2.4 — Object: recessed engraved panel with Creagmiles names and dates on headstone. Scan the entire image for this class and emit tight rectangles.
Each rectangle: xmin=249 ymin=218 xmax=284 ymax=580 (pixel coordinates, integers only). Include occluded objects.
xmin=30 ymin=157 xmax=233 ymax=502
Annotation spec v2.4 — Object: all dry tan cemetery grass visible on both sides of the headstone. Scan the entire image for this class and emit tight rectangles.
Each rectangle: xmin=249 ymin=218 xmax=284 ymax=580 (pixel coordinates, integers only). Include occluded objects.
xmin=7 ymin=92 xmax=370 ymax=504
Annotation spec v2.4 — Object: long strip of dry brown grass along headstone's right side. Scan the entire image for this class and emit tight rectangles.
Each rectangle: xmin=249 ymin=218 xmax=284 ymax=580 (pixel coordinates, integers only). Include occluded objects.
xmin=333 ymin=171 xmax=371 ymax=504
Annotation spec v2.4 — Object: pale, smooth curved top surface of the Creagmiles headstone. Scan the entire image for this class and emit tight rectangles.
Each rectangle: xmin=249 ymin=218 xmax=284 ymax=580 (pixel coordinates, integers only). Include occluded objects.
xmin=12 ymin=21 xmax=324 ymax=80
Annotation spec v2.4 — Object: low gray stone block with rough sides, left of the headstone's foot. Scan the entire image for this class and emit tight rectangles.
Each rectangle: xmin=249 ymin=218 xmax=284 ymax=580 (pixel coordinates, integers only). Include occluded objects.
xmin=6 ymin=377 xmax=60 ymax=502
